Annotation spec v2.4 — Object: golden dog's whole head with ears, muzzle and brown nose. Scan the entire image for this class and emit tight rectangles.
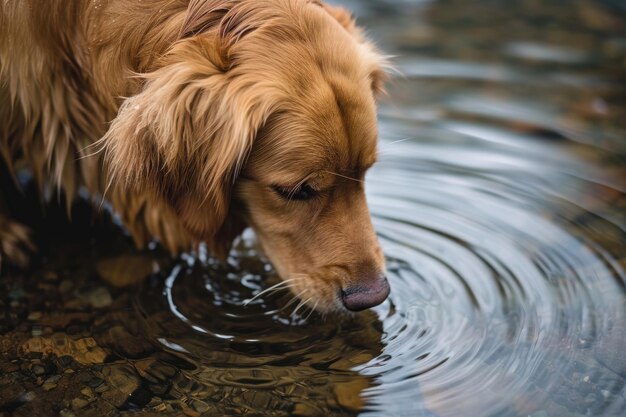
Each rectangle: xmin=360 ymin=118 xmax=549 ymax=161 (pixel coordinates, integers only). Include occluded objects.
xmin=104 ymin=0 xmax=389 ymax=311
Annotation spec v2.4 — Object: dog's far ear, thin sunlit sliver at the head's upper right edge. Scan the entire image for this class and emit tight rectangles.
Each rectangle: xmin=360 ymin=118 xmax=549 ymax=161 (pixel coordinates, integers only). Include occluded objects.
xmin=312 ymin=0 xmax=390 ymax=96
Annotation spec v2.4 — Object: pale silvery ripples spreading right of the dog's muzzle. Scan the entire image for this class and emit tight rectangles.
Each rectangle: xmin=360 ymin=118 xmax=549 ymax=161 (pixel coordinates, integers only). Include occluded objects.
xmin=360 ymin=132 xmax=626 ymax=416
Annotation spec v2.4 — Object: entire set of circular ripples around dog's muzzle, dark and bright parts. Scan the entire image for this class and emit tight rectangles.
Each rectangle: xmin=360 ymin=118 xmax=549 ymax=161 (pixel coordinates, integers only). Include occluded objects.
xmin=136 ymin=130 xmax=626 ymax=416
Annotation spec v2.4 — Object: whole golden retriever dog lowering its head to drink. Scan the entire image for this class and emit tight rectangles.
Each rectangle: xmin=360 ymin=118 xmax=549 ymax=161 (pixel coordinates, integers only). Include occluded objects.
xmin=0 ymin=0 xmax=389 ymax=312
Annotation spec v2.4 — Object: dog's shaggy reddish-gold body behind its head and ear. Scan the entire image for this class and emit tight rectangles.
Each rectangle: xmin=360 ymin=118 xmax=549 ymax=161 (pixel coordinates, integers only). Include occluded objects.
xmin=0 ymin=0 xmax=195 ymax=258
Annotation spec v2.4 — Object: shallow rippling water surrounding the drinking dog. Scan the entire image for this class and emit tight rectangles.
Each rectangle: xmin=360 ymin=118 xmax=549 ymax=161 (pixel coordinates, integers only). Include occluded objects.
xmin=0 ymin=0 xmax=626 ymax=417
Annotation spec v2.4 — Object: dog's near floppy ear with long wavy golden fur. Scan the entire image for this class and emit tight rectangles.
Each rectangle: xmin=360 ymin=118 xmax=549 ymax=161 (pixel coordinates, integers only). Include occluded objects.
xmin=102 ymin=37 xmax=271 ymax=250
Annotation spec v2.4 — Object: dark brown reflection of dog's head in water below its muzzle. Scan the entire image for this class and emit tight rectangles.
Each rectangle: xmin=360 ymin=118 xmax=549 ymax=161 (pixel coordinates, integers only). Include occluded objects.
xmin=135 ymin=237 xmax=383 ymax=415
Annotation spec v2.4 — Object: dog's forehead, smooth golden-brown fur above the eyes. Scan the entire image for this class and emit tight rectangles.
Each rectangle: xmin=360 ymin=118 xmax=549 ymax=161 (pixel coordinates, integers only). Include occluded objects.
xmin=249 ymin=83 xmax=378 ymax=184
